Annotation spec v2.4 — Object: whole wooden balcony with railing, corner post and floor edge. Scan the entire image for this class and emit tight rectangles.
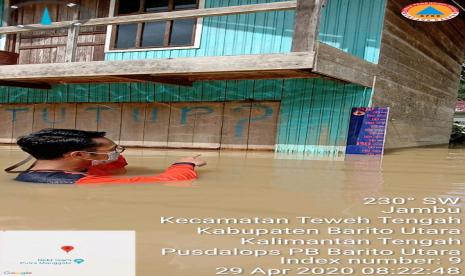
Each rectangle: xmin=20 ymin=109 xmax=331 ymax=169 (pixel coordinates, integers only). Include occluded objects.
xmin=0 ymin=0 xmax=377 ymax=89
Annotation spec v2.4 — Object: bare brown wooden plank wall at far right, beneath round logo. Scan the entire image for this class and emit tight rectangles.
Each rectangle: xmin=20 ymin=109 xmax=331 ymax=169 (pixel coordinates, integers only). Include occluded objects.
xmin=373 ymin=0 xmax=465 ymax=148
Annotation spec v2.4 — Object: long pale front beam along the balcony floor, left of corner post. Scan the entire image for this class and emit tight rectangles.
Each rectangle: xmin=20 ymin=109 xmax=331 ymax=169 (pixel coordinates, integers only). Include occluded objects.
xmin=0 ymin=52 xmax=314 ymax=78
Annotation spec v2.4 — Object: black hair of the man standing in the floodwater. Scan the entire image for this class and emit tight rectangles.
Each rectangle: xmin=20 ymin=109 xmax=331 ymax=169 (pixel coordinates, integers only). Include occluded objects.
xmin=16 ymin=128 xmax=105 ymax=160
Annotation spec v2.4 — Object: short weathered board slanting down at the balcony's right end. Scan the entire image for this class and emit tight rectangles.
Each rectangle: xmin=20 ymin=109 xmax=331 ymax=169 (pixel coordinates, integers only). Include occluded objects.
xmin=312 ymin=42 xmax=379 ymax=87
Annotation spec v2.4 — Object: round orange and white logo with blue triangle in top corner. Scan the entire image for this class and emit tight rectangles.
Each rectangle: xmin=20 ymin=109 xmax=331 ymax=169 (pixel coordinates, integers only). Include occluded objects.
xmin=402 ymin=2 xmax=459 ymax=22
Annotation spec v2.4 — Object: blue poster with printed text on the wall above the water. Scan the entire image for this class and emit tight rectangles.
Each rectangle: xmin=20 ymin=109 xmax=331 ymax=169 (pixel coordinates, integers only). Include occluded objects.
xmin=346 ymin=107 xmax=389 ymax=155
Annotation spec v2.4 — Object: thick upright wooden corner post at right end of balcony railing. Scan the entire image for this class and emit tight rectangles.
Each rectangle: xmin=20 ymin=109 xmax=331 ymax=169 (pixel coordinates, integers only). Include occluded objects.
xmin=292 ymin=0 xmax=326 ymax=52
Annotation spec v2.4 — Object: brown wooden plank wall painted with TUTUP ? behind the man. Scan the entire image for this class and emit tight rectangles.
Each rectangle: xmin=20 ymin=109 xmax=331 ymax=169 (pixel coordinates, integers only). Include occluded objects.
xmin=0 ymin=101 xmax=279 ymax=149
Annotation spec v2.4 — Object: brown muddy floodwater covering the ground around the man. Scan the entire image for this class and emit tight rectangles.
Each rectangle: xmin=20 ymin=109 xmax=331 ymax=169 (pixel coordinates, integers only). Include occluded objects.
xmin=0 ymin=146 xmax=465 ymax=276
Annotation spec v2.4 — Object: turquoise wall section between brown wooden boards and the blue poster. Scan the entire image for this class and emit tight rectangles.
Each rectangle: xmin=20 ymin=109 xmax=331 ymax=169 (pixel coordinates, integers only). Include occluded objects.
xmin=276 ymin=79 xmax=372 ymax=155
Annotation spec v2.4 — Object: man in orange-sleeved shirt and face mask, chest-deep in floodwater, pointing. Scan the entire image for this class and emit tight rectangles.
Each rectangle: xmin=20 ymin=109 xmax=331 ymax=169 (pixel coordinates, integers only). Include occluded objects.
xmin=7 ymin=129 xmax=206 ymax=184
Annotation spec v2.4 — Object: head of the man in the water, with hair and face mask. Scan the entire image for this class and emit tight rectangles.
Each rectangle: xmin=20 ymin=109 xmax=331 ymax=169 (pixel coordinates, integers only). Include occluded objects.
xmin=17 ymin=128 xmax=117 ymax=162
